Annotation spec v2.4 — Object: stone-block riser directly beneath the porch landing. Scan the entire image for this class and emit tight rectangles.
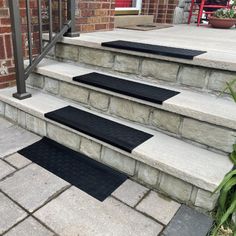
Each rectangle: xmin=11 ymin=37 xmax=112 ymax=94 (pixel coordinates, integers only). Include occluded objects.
xmin=51 ymin=43 xmax=236 ymax=97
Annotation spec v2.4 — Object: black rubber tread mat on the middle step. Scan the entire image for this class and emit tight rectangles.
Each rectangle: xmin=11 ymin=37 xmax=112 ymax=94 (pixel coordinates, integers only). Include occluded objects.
xmin=73 ymin=72 xmax=179 ymax=104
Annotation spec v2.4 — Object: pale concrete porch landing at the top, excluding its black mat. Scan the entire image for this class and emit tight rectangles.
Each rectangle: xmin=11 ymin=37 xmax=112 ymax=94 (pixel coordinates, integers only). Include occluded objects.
xmin=58 ymin=25 xmax=236 ymax=71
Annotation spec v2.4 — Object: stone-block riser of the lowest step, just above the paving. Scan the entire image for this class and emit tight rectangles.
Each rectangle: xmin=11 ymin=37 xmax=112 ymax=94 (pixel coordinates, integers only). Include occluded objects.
xmin=0 ymin=97 xmax=221 ymax=211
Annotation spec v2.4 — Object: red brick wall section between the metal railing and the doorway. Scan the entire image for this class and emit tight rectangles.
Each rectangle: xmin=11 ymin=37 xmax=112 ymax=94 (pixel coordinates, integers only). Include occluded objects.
xmin=76 ymin=0 xmax=115 ymax=32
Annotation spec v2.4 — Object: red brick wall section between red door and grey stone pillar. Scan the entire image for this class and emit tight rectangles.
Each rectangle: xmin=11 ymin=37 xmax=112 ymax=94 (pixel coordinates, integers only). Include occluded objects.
xmin=142 ymin=0 xmax=178 ymax=23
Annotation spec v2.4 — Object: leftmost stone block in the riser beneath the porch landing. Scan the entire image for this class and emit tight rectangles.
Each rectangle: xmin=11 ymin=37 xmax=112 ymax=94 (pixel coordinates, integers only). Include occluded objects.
xmin=56 ymin=44 xmax=79 ymax=61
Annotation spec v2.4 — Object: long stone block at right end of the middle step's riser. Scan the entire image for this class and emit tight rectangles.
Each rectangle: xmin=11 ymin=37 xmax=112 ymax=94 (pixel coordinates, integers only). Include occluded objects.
xmin=182 ymin=118 xmax=236 ymax=152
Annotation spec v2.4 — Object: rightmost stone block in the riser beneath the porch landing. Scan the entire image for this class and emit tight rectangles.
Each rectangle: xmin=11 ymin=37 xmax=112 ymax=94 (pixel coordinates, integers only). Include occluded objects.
xmin=208 ymin=70 xmax=236 ymax=93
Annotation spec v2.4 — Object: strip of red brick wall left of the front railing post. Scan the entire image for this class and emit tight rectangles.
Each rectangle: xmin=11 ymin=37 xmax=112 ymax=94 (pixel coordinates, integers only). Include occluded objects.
xmin=0 ymin=0 xmax=15 ymax=89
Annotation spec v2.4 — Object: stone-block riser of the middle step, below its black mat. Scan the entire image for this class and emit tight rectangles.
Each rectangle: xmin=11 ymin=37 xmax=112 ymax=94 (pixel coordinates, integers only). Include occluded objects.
xmin=27 ymin=71 xmax=236 ymax=155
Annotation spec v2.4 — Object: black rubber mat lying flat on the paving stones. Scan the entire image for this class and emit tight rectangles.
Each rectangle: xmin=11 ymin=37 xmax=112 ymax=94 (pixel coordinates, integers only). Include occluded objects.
xmin=19 ymin=138 xmax=127 ymax=201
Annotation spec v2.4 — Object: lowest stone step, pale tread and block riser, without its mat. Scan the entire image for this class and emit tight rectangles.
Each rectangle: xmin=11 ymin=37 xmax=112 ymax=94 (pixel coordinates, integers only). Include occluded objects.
xmin=0 ymin=88 xmax=232 ymax=210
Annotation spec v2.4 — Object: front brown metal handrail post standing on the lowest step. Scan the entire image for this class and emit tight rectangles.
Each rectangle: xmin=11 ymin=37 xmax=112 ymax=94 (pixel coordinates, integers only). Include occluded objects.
xmin=9 ymin=0 xmax=31 ymax=100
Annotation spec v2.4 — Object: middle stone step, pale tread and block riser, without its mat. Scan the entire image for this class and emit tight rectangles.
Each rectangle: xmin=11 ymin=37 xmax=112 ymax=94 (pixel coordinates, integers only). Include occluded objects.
xmin=27 ymin=59 xmax=236 ymax=152
